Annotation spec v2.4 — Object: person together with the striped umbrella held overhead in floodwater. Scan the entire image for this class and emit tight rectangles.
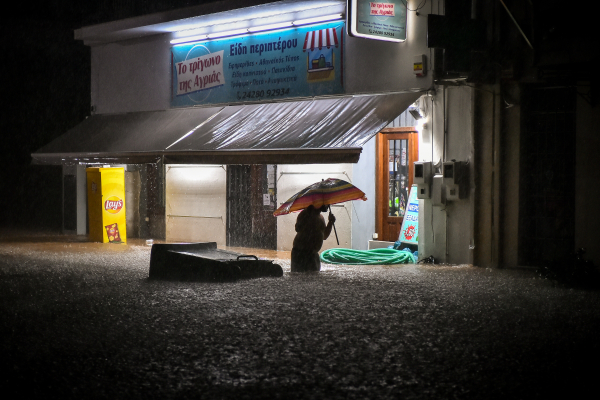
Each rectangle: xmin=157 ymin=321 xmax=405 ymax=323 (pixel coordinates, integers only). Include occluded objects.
xmin=273 ymin=178 xmax=367 ymax=272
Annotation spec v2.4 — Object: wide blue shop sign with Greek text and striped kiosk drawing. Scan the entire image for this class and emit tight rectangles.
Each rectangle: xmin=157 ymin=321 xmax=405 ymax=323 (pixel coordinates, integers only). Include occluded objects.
xmin=171 ymin=21 xmax=345 ymax=107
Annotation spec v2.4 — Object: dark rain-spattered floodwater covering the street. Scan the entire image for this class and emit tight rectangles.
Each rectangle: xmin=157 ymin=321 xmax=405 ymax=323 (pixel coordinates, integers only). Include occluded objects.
xmin=0 ymin=231 xmax=600 ymax=399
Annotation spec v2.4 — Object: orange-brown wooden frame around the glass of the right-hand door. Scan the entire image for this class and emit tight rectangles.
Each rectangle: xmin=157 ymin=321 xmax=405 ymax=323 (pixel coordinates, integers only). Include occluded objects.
xmin=375 ymin=127 xmax=419 ymax=240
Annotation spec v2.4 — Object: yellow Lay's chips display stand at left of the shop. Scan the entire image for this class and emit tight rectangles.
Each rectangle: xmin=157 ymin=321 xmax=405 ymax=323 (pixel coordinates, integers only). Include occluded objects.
xmin=86 ymin=168 xmax=127 ymax=243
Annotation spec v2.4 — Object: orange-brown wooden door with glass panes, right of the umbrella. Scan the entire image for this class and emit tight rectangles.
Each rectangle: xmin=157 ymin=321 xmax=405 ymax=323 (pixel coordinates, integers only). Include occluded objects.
xmin=375 ymin=127 xmax=419 ymax=242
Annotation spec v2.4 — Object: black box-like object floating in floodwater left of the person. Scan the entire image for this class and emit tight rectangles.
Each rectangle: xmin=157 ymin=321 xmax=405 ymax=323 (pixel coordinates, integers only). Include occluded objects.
xmin=149 ymin=242 xmax=283 ymax=282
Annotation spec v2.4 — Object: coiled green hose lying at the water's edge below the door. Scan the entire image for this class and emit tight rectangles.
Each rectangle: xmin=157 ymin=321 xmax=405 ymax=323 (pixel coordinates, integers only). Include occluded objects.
xmin=320 ymin=248 xmax=416 ymax=265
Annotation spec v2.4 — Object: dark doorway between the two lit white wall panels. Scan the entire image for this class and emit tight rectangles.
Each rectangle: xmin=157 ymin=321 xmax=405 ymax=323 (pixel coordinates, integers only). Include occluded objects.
xmin=226 ymin=165 xmax=277 ymax=250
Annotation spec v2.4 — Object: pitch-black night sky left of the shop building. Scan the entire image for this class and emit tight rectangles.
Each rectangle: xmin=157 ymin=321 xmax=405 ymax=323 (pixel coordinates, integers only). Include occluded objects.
xmin=0 ymin=0 xmax=207 ymax=230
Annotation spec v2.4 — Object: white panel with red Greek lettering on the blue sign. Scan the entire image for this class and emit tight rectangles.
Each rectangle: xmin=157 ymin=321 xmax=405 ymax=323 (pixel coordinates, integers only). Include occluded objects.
xmin=175 ymin=50 xmax=225 ymax=95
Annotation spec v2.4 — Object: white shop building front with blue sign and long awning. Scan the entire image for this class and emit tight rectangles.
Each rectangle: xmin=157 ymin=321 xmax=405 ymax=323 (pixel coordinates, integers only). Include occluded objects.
xmin=32 ymin=1 xmax=433 ymax=253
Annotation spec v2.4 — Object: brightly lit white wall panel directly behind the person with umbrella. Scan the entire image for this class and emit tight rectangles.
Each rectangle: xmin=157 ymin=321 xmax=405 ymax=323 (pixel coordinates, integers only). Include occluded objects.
xmin=277 ymin=164 xmax=353 ymax=251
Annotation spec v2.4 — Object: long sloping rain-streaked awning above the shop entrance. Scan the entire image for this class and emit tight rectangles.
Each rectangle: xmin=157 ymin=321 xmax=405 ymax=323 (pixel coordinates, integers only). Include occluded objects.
xmin=31 ymin=92 xmax=420 ymax=165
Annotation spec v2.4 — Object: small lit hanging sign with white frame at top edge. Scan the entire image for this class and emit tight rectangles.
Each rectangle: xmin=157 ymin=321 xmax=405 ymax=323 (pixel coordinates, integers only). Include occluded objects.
xmin=348 ymin=0 xmax=407 ymax=42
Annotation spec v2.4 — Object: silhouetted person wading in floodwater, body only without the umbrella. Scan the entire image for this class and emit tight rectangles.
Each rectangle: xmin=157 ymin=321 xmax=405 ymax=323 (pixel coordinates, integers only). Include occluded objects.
xmin=291 ymin=205 xmax=335 ymax=272
